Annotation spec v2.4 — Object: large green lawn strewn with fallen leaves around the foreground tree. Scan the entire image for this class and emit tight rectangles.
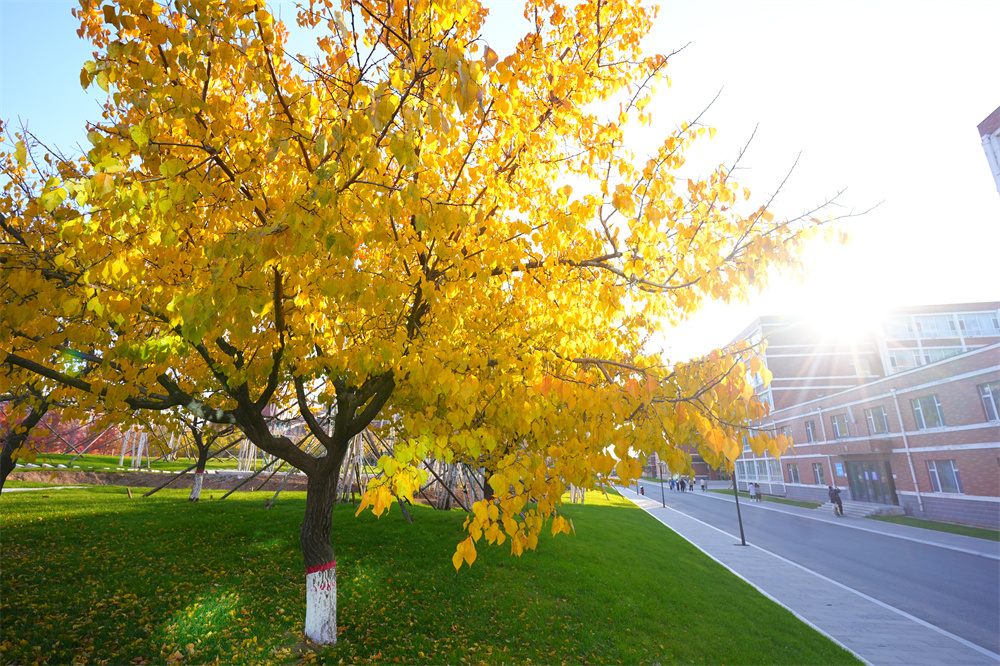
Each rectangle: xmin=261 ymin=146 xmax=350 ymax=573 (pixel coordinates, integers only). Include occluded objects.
xmin=0 ymin=487 xmax=857 ymax=664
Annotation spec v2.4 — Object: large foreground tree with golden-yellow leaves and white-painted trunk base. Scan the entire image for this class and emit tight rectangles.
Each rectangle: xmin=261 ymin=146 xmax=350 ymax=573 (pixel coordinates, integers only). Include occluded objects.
xmin=0 ymin=0 xmax=820 ymax=643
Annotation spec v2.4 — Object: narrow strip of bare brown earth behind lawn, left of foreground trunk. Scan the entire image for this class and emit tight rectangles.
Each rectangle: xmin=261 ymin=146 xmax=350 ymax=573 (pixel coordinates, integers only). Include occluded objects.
xmin=7 ymin=469 xmax=308 ymax=491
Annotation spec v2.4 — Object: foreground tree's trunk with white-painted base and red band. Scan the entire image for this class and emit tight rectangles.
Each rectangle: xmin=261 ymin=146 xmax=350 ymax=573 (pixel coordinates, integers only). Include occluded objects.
xmin=300 ymin=470 xmax=338 ymax=645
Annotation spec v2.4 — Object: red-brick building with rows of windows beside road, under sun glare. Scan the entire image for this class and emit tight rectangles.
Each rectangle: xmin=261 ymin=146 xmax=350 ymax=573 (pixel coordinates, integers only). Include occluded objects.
xmin=736 ymin=302 xmax=1000 ymax=528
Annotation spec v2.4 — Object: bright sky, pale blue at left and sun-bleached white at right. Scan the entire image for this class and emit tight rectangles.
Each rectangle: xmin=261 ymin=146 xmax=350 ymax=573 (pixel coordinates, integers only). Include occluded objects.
xmin=0 ymin=0 xmax=1000 ymax=360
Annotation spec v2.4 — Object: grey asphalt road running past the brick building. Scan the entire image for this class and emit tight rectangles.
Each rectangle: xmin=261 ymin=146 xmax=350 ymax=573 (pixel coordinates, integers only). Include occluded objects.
xmin=643 ymin=483 xmax=1000 ymax=653
